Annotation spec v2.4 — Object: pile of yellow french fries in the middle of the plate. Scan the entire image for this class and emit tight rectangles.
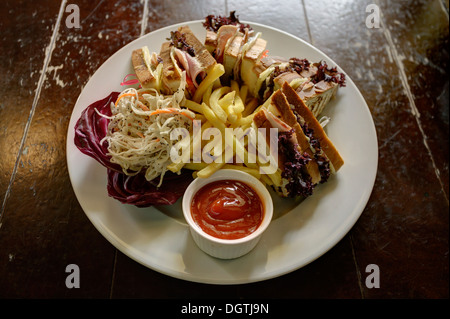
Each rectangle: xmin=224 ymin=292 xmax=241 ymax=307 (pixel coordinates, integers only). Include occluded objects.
xmin=167 ymin=64 xmax=281 ymax=185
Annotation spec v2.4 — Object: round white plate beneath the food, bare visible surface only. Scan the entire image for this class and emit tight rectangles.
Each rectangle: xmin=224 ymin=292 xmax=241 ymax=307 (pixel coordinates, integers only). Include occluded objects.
xmin=67 ymin=21 xmax=378 ymax=284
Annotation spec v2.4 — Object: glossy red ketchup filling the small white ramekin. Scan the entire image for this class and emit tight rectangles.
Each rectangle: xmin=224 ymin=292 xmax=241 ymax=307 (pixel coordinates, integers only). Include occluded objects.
xmin=191 ymin=180 xmax=264 ymax=239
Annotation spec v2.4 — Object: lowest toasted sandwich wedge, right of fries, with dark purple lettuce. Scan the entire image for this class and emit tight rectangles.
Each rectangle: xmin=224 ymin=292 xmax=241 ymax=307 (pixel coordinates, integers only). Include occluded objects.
xmin=253 ymin=83 xmax=344 ymax=197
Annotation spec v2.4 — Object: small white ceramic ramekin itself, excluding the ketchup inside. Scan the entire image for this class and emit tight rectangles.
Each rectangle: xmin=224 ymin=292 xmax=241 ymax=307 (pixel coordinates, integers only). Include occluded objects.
xmin=182 ymin=169 xmax=273 ymax=259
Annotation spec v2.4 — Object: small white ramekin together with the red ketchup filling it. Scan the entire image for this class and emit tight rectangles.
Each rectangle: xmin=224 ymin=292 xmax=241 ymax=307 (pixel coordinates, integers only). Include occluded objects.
xmin=182 ymin=169 xmax=273 ymax=259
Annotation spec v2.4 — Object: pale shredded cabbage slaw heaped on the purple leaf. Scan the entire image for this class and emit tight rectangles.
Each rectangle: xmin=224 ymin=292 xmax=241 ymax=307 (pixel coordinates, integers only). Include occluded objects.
xmin=96 ymin=72 xmax=195 ymax=187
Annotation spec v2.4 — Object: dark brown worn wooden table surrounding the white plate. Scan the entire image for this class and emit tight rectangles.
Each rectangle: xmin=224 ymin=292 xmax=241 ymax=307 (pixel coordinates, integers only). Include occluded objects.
xmin=0 ymin=0 xmax=449 ymax=300
